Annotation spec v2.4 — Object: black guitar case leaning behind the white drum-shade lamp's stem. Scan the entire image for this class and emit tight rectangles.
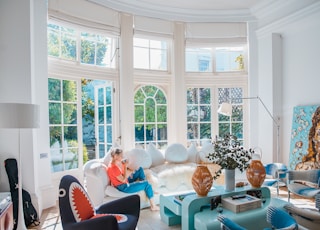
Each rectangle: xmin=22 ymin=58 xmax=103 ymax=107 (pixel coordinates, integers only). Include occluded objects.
xmin=4 ymin=158 xmax=40 ymax=230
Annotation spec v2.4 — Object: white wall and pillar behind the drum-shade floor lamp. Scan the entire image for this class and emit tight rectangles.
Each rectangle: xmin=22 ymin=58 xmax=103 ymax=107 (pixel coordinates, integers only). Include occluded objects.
xmin=0 ymin=0 xmax=57 ymax=214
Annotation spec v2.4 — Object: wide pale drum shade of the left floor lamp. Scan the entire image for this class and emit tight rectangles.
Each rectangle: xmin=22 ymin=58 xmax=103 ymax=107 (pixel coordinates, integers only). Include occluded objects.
xmin=0 ymin=103 xmax=40 ymax=129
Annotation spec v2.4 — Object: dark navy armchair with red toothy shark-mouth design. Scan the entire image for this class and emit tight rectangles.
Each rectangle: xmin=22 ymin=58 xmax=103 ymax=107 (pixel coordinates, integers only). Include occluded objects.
xmin=59 ymin=175 xmax=140 ymax=230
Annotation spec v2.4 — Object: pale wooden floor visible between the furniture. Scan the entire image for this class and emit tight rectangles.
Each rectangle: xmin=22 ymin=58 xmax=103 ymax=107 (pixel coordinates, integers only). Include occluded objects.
xmin=28 ymin=187 xmax=314 ymax=230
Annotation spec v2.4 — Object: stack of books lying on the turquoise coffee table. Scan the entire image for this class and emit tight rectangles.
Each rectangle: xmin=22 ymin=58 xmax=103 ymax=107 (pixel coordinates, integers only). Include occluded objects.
xmin=222 ymin=194 xmax=261 ymax=213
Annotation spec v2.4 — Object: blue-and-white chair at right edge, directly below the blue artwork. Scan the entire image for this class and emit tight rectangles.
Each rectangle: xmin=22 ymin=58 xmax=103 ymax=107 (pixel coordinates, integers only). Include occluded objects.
xmin=287 ymin=169 xmax=320 ymax=202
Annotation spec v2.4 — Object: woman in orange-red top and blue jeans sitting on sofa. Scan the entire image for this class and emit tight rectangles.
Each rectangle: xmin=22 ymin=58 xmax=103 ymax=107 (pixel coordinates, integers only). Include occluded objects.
xmin=106 ymin=148 xmax=159 ymax=211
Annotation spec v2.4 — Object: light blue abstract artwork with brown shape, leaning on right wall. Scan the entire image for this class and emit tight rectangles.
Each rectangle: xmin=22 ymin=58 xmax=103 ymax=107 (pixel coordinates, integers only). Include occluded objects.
xmin=288 ymin=105 xmax=320 ymax=170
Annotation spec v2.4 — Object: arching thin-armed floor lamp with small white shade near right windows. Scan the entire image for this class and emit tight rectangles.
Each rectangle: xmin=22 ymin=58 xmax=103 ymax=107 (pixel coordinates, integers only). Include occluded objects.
xmin=218 ymin=96 xmax=280 ymax=162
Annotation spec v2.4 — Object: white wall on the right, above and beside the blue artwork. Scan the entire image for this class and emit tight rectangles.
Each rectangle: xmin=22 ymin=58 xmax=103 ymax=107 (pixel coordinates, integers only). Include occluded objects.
xmin=257 ymin=2 xmax=320 ymax=164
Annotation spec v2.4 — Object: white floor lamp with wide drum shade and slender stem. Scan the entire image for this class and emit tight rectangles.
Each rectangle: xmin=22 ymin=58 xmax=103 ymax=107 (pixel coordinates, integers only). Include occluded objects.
xmin=0 ymin=103 xmax=40 ymax=230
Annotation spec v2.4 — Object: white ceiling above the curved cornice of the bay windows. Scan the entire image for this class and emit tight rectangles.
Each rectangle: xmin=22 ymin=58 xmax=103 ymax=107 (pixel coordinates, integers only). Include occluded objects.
xmin=88 ymin=0 xmax=264 ymax=22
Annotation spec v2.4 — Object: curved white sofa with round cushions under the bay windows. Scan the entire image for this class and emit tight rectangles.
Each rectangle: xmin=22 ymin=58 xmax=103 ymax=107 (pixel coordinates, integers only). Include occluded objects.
xmin=84 ymin=144 xmax=204 ymax=208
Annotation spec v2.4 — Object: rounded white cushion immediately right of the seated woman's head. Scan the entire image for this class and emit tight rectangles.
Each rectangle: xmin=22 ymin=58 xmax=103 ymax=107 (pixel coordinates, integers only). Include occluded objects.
xmin=127 ymin=149 xmax=152 ymax=170
